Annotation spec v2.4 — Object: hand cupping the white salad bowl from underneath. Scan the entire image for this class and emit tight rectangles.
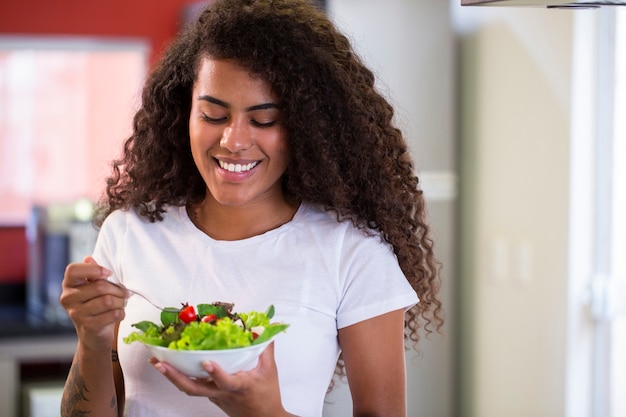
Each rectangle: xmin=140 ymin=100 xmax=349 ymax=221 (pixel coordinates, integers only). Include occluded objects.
xmin=151 ymin=342 xmax=290 ymax=417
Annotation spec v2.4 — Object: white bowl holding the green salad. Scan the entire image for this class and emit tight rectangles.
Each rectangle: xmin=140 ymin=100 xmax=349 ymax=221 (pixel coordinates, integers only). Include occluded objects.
xmin=144 ymin=339 xmax=272 ymax=378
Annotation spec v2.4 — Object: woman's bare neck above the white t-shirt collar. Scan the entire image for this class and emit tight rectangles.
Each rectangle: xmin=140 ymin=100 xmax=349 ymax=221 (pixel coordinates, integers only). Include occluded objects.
xmin=187 ymin=195 xmax=299 ymax=240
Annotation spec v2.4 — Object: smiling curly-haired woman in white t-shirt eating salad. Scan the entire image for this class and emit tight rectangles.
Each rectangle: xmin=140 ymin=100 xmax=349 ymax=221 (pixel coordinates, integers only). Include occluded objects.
xmin=61 ymin=0 xmax=442 ymax=417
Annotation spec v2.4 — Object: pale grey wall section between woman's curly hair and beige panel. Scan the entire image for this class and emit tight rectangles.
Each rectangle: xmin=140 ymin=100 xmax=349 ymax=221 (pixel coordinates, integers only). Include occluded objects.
xmin=324 ymin=0 xmax=457 ymax=417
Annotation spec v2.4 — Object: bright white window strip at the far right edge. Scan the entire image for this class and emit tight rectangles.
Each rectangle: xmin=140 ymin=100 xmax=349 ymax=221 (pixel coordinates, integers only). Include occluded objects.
xmin=566 ymin=7 xmax=626 ymax=417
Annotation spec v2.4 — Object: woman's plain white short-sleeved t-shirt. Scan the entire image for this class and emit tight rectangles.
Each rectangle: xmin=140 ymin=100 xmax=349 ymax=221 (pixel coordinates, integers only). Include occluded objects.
xmin=94 ymin=200 xmax=417 ymax=417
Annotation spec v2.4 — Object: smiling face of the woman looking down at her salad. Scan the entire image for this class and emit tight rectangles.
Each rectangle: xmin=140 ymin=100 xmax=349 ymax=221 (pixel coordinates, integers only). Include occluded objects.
xmin=189 ymin=58 xmax=288 ymax=206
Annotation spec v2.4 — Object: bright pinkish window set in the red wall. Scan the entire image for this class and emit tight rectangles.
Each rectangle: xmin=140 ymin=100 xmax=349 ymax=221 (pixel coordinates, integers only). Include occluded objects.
xmin=0 ymin=37 xmax=148 ymax=224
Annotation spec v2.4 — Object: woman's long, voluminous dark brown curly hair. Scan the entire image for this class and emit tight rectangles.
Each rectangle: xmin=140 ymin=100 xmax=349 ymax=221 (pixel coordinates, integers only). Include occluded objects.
xmin=97 ymin=0 xmax=443 ymax=362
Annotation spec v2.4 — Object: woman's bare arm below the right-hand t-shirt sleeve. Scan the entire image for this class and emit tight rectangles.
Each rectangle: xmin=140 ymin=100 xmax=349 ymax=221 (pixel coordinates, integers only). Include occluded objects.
xmin=339 ymin=310 xmax=406 ymax=417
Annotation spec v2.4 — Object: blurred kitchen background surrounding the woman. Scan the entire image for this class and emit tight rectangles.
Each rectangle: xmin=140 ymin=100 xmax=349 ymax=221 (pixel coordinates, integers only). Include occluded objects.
xmin=0 ymin=0 xmax=626 ymax=417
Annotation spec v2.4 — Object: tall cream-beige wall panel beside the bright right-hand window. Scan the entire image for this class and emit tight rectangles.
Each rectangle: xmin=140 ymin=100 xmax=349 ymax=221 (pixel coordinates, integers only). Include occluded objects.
xmin=452 ymin=6 xmax=592 ymax=417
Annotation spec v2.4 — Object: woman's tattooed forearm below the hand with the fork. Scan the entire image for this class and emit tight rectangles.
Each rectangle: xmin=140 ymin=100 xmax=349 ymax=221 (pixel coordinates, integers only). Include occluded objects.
xmin=61 ymin=343 xmax=119 ymax=417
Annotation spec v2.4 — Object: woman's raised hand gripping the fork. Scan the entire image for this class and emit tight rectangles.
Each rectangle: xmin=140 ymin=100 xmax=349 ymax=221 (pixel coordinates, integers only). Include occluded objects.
xmin=60 ymin=257 xmax=129 ymax=351
